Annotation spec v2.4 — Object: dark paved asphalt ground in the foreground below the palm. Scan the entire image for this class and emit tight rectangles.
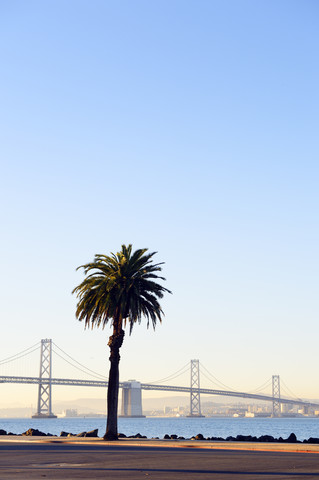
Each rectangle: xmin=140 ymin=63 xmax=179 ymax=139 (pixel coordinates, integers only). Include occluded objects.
xmin=0 ymin=441 xmax=319 ymax=480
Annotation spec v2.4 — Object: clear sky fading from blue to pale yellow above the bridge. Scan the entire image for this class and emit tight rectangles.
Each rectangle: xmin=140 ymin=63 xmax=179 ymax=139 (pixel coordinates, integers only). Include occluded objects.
xmin=0 ymin=0 xmax=319 ymax=406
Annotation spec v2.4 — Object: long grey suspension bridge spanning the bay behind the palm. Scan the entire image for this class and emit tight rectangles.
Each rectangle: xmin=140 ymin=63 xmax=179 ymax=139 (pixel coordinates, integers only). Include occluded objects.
xmin=0 ymin=339 xmax=319 ymax=418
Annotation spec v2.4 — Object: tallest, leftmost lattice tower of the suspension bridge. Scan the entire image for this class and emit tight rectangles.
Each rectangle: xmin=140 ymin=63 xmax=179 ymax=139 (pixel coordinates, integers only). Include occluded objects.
xmin=32 ymin=338 xmax=56 ymax=418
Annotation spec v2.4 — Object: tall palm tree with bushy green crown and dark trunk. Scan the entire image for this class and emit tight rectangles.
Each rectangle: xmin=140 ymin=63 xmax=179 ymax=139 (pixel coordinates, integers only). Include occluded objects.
xmin=72 ymin=245 xmax=171 ymax=440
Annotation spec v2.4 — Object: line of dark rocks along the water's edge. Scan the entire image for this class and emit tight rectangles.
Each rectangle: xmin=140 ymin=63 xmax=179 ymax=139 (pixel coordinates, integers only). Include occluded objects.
xmin=0 ymin=428 xmax=319 ymax=444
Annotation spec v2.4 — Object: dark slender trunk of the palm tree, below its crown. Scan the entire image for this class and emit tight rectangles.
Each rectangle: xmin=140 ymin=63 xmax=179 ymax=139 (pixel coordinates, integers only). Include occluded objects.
xmin=103 ymin=329 xmax=124 ymax=440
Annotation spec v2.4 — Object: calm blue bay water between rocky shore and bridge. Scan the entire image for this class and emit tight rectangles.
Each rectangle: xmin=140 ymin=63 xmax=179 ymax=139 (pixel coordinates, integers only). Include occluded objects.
xmin=0 ymin=417 xmax=319 ymax=440
